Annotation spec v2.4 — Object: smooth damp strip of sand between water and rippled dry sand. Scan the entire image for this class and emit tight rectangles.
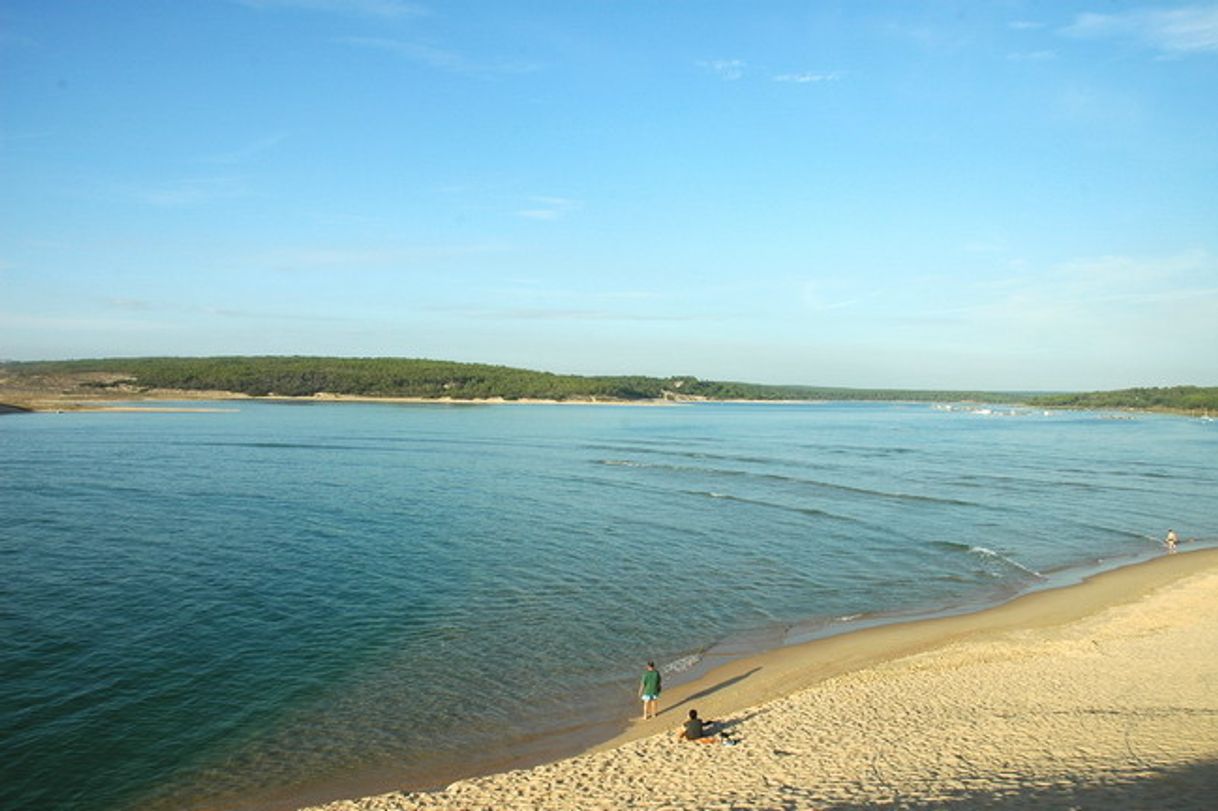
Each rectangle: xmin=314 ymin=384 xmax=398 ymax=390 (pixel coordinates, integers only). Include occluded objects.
xmin=242 ymin=548 xmax=1218 ymax=811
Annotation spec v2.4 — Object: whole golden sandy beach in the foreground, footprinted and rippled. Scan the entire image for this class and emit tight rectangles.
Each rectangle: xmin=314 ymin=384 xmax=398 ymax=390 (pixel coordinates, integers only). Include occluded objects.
xmin=306 ymin=550 xmax=1218 ymax=811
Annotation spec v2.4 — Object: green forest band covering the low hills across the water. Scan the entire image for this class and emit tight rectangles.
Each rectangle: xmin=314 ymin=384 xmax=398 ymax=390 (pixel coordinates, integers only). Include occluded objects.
xmin=0 ymin=356 xmax=1218 ymax=413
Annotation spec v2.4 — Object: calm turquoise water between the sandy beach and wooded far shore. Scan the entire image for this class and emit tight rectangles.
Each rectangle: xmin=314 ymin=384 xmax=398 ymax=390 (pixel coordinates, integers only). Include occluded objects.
xmin=0 ymin=402 xmax=1218 ymax=810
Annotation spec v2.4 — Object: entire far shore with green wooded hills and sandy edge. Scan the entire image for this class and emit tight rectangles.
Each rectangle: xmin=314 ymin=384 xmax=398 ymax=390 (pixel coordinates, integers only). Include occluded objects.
xmin=0 ymin=356 xmax=1218 ymax=420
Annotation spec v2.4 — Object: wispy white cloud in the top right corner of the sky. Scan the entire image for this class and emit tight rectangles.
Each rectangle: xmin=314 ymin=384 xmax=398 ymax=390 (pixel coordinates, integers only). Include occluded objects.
xmin=1061 ymin=5 xmax=1218 ymax=56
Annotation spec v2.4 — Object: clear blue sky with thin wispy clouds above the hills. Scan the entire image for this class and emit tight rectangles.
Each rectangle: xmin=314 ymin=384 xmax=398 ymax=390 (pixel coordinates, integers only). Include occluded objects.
xmin=0 ymin=0 xmax=1218 ymax=390
